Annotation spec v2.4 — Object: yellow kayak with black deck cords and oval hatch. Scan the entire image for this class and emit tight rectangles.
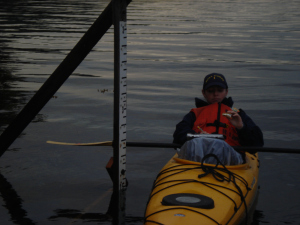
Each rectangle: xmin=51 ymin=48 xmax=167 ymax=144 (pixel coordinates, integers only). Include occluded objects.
xmin=144 ymin=153 xmax=259 ymax=225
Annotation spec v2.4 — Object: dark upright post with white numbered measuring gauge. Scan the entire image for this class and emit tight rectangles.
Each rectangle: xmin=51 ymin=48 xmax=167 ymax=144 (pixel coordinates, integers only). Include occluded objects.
xmin=112 ymin=0 xmax=127 ymax=224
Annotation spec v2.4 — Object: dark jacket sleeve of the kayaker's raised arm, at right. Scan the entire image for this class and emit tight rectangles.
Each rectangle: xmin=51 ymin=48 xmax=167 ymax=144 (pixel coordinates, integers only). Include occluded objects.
xmin=237 ymin=109 xmax=264 ymax=147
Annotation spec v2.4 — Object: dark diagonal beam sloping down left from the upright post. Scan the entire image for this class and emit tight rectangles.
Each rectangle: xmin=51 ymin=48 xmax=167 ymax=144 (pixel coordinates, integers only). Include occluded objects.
xmin=0 ymin=0 xmax=131 ymax=157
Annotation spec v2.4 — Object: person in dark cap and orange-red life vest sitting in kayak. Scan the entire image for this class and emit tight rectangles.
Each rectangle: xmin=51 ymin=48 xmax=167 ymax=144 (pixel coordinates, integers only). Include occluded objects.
xmin=173 ymin=73 xmax=264 ymax=147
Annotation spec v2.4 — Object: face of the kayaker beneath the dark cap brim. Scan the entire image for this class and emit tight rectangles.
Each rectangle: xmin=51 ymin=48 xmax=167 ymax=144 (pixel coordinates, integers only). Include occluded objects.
xmin=202 ymin=86 xmax=228 ymax=104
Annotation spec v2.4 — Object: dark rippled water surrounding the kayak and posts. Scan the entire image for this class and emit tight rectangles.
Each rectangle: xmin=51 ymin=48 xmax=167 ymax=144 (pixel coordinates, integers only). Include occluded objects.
xmin=0 ymin=0 xmax=300 ymax=225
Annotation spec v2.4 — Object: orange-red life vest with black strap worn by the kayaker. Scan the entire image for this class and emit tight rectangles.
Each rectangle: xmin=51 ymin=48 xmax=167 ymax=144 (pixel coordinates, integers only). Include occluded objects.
xmin=191 ymin=103 xmax=240 ymax=146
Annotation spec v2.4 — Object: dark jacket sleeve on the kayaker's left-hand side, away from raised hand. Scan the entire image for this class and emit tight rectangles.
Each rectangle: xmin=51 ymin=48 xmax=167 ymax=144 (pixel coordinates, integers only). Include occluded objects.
xmin=173 ymin=112 xmax=196 ymax=145
